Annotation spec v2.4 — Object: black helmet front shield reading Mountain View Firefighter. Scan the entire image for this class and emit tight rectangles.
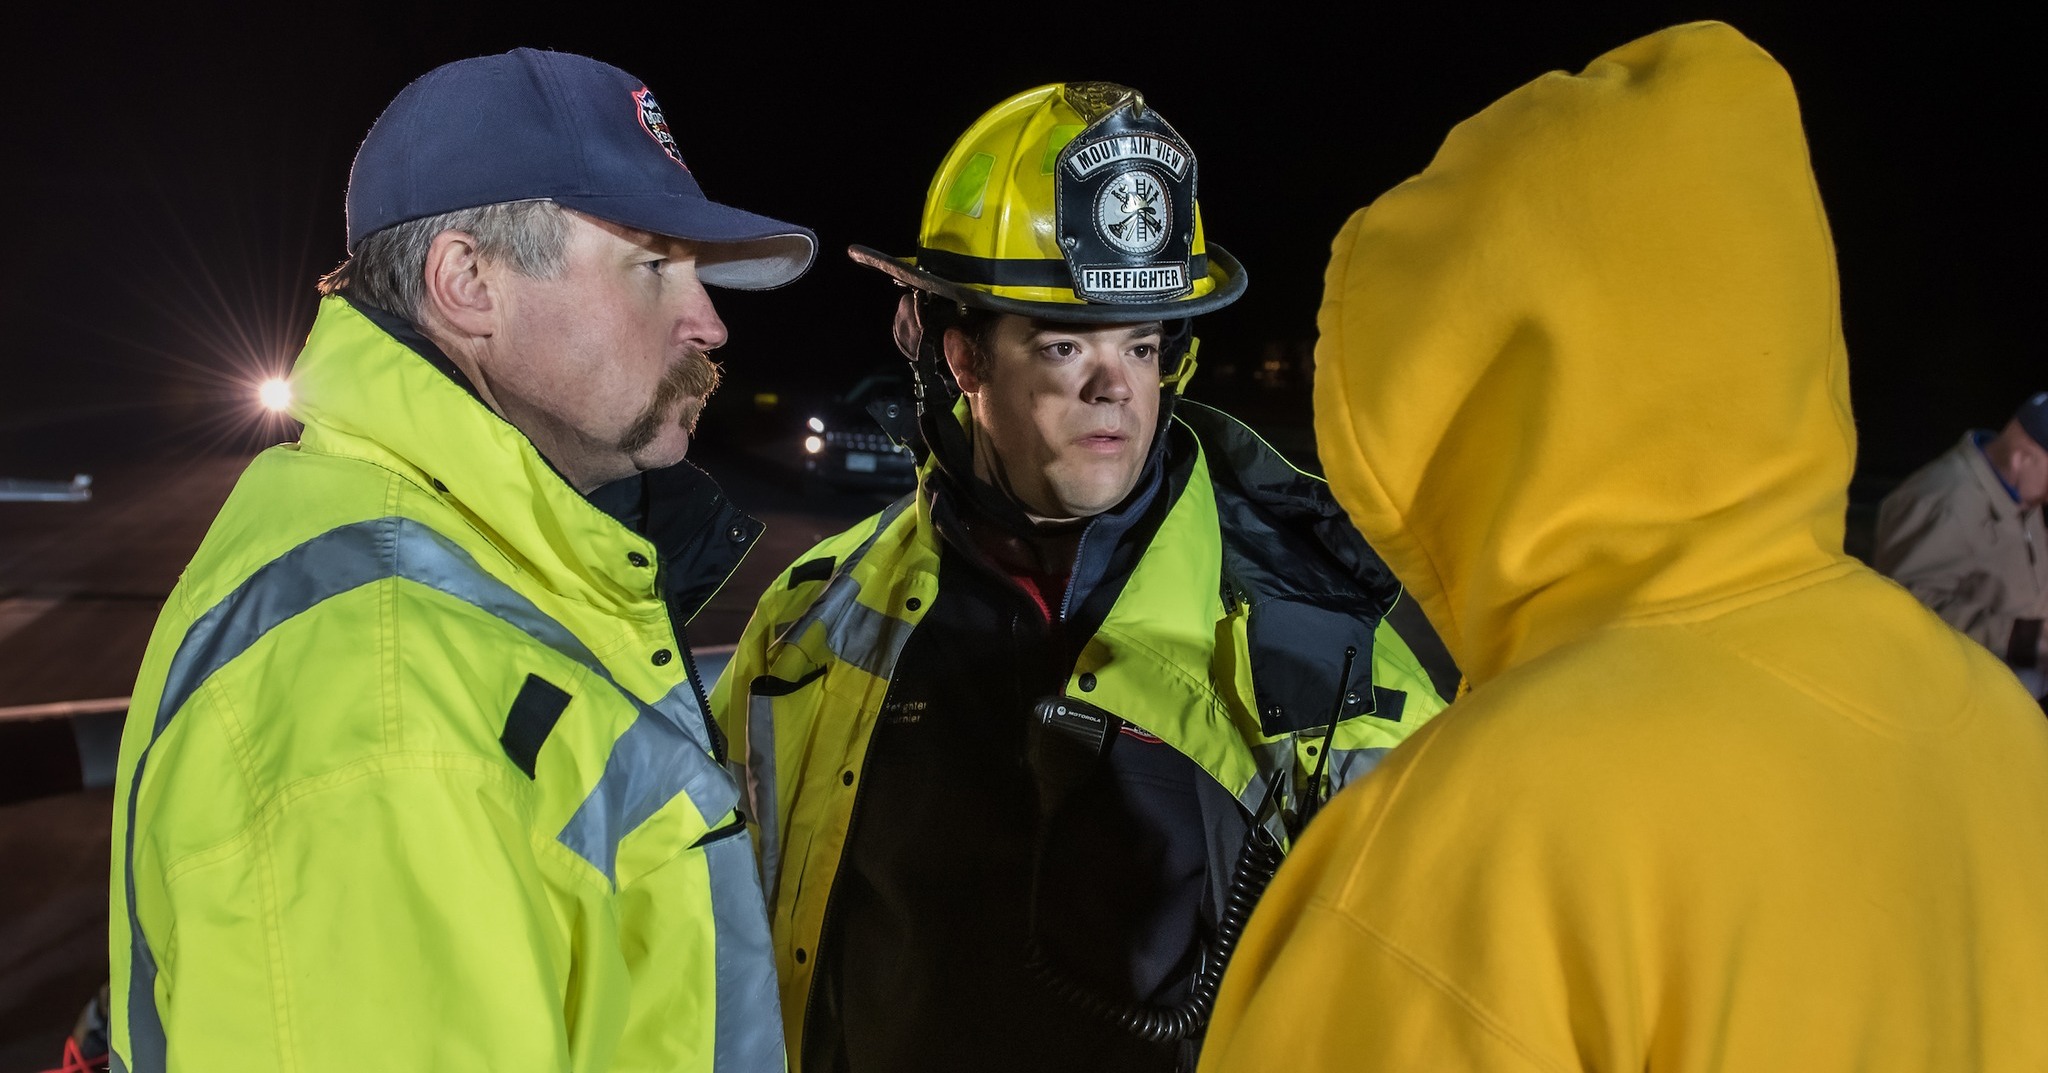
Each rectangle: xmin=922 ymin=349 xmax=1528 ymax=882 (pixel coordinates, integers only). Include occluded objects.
xmin=1053 ymin=94 xmax=1194 ymax=303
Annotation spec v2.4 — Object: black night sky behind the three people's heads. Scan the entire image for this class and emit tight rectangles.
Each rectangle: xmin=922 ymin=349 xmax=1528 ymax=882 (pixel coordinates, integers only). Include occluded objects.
xmin=0 ymin=2 xmax=2048 ymax=481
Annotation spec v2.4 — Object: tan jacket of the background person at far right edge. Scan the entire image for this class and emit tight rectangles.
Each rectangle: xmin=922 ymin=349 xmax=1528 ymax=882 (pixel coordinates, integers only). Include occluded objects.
xmin=1872 ymin=434 xmax=2048 ymax=694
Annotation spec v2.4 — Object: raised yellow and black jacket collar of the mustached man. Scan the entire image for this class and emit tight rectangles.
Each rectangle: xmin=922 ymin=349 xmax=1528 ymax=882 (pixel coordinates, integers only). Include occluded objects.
xmin=293 ymin=297 xmax=762 ymax=618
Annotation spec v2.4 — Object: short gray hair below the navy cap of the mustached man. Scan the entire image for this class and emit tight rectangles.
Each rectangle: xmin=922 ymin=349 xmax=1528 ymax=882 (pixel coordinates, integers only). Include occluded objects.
xmin=319 ymin=199 xmax=569 ymax=324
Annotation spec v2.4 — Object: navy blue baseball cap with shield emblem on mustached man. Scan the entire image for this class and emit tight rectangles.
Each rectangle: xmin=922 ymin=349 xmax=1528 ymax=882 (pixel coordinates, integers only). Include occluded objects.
xmin=348 ymin=49 xmax=817 ymax=291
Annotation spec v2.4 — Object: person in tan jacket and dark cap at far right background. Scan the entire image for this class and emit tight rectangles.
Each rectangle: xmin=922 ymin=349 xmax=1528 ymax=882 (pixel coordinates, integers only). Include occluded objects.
xmin=1872 ymin=391 xmax=2048 ymax=698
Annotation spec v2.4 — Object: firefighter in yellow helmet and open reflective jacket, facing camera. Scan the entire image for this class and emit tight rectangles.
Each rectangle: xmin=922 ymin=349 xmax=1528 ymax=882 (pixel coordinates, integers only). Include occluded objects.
xmin=713 ymin=82 xmax=1450 ymax=1073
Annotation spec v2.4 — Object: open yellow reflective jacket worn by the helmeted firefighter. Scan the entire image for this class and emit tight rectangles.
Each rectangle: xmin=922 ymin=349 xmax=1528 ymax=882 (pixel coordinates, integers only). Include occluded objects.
xmin=711 ymin=401 xmax=1450 ymax=1065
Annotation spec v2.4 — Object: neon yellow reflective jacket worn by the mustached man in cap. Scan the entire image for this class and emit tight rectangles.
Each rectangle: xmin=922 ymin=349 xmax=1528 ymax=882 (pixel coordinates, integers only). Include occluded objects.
xmin=111 ymin=299 xmax=782 ymax=1073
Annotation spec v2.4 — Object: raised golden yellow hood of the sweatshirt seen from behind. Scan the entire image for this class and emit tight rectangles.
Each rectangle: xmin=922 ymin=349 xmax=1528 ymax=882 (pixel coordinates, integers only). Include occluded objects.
xmin=1315 ymin=23 xmax=1855 ymax=686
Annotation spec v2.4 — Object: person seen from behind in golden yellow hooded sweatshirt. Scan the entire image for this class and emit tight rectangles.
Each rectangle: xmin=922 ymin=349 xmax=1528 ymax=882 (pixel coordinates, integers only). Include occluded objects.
xmin=1202 ymin=23 xmax=2048 ymax=1073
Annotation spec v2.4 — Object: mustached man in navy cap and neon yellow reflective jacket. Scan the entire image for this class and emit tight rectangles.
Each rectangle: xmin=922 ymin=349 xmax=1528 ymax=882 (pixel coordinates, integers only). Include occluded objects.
xmin=111 ymin=49 xmax=815 ymax=1073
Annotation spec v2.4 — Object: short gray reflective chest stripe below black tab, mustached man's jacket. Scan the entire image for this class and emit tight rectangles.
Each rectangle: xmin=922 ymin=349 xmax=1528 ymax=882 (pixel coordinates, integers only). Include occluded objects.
xmin=559 ymin=680 xmax=739 ymax=885
